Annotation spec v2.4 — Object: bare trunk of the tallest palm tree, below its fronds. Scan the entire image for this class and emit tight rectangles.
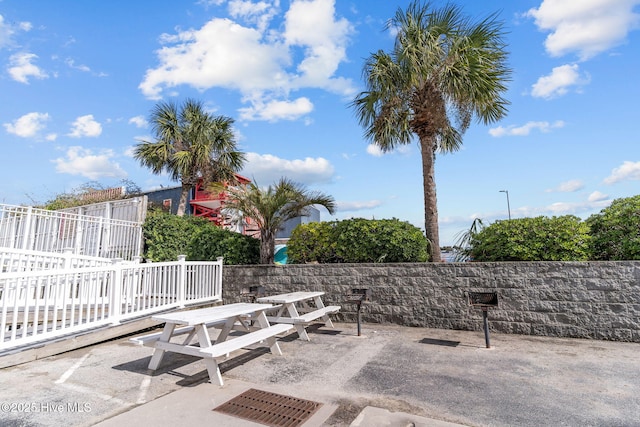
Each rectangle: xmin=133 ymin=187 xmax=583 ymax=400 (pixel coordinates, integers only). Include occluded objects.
xmin=420 ymin=136 xmax=442 ymax=262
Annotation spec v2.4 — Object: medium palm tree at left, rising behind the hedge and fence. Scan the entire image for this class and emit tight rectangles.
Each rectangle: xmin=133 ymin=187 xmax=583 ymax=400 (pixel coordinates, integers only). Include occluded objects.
xmin=134 ymin=99 xmax=244 ymax=216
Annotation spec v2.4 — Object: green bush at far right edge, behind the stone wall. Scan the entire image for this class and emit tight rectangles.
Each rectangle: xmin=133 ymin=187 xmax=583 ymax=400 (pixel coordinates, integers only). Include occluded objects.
xmin=586 ymin=195 xmax=640 ymax=260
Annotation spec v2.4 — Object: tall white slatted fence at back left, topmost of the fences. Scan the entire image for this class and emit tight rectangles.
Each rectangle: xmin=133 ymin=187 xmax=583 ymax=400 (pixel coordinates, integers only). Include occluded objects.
xmin=0 ymin=204 xmax=142 ymax=260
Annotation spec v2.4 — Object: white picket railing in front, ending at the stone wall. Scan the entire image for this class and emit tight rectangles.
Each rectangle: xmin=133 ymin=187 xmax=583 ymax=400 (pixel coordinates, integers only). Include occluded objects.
xmin=0 ymin=257 xmax=222 ymax=350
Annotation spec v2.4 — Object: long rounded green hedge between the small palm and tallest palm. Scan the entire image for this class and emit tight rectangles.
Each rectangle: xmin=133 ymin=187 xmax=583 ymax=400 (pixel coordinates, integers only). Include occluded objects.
xmin=287 ymin=219 xmax=427 ymax=263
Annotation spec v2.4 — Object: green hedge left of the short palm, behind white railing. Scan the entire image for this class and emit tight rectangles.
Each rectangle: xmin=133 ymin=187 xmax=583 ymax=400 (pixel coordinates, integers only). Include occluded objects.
xmin=143 ymin=211 xmax=259 ymax=264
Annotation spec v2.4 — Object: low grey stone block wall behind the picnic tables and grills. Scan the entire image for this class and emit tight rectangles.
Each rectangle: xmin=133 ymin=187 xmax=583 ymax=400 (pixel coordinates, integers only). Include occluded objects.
xmin=223 ymin=261 xmax=640 ymax=342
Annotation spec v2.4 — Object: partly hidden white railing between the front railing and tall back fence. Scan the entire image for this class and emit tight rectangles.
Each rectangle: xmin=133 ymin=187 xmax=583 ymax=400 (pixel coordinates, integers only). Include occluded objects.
xmin=0 ymin=247 xmax=115 ymax=273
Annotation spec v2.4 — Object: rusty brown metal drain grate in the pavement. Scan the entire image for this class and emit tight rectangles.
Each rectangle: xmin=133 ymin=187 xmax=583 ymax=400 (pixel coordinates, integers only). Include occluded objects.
xmin=214 ymin=388 xmax=322 ymax=427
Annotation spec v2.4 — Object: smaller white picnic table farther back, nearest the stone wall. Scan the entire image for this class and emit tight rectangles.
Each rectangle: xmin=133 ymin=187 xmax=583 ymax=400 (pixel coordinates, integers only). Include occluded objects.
xmin=256 ymin=292 xmax=340 ymax=341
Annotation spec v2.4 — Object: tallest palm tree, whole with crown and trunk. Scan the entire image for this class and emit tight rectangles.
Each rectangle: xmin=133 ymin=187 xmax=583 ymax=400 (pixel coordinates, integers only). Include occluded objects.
xmin=352 ymin=1 xmax=511 ymax=261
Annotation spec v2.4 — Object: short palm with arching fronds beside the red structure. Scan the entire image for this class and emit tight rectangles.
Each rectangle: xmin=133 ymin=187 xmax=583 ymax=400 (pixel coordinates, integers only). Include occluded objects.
xmin=224 ymin=178 xmax=335 ymax=264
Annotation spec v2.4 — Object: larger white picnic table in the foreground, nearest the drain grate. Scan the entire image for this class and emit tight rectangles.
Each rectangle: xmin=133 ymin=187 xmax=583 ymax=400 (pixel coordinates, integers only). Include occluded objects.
xmin=131 ymin=303 xmax=293 ymax=386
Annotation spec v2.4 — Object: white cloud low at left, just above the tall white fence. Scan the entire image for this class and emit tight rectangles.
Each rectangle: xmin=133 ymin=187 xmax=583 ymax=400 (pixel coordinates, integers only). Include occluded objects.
xmin=52 ymin=146 xmax=127 ymax=180
